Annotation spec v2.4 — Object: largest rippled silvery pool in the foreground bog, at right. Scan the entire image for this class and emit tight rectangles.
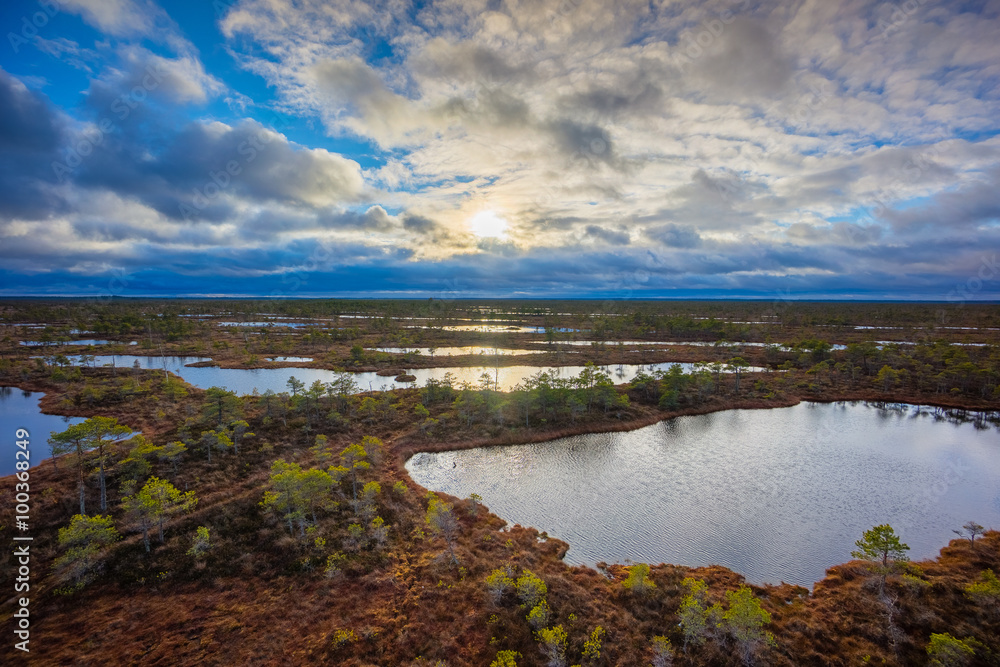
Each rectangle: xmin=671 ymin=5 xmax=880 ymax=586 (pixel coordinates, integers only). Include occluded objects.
xmin=406 ymin=403 xmax=1000 ymax=586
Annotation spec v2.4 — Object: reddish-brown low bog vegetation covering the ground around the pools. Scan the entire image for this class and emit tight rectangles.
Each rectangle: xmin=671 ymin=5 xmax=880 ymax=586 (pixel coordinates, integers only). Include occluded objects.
xmin=0 ymin=300 xmax=1000 ymax=667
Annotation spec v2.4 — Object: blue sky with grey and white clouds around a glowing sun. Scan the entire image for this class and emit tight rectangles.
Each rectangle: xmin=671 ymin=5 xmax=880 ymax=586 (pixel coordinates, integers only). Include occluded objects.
xmin=0 ymin=0 xmax=1000 ymax=302
